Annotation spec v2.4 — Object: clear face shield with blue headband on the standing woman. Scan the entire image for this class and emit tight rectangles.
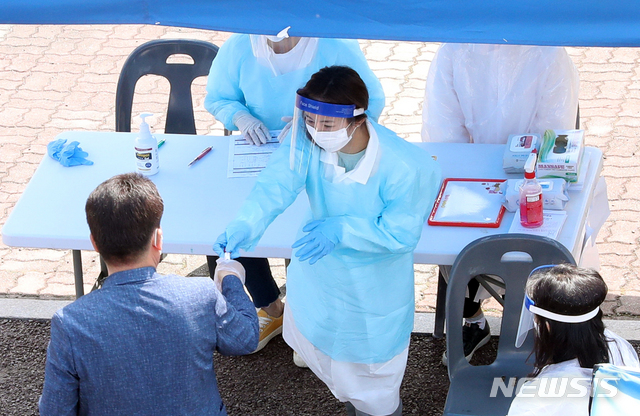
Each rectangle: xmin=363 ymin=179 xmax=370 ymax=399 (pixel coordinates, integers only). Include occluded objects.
xmin=290 ymin=95 xmax=364 ymax=173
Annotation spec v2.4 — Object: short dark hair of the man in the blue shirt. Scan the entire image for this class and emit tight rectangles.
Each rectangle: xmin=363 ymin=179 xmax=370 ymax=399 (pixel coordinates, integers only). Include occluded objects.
xmin=85 ymin=173 xmax=164 ymax=264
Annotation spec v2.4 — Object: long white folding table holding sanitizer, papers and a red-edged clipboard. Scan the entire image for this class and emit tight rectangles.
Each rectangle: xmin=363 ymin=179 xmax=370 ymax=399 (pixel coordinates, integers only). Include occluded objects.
xmin=2 ymin=132 xmax=602 ymax=296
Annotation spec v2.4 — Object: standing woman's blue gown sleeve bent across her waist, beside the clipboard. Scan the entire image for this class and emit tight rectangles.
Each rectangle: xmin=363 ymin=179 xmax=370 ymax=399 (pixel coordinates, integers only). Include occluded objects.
xmin=329 ymin=161 xmax=441 ymax=253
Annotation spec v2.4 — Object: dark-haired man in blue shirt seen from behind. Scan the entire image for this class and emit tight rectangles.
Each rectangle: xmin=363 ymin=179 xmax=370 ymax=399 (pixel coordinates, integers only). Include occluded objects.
xmin=40 ymin=173 xmax=258 ymax=416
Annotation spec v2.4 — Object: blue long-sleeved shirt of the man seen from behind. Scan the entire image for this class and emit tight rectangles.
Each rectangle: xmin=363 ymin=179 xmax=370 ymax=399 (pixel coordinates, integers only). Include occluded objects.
xmin=40 ymin=267 xmax=258 ymax=416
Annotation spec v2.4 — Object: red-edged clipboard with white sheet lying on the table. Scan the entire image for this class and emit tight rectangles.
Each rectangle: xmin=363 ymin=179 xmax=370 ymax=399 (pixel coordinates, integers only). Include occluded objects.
xmin=428 ymin=178 xmax=506 ymax=228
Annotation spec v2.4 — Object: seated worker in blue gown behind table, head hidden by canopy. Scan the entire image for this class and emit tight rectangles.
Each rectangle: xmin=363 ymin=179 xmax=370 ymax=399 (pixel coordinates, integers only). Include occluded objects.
xmin=205 ymin=34 xmax=384 ymax=354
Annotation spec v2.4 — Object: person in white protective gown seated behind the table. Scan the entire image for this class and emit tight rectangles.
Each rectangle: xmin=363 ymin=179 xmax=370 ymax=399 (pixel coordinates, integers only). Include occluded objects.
xmin=422 ymin=43 xmax=588 ymax=365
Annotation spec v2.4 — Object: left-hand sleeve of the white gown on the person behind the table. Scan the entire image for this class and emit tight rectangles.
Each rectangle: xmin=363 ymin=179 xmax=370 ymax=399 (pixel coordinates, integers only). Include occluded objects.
xmin=422 ymin=45 xmax=469 ymax=143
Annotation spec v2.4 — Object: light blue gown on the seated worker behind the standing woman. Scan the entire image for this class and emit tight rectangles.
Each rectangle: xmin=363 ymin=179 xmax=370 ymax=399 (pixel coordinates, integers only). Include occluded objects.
xmin=204 ymin=34 xmax=384 ymax=130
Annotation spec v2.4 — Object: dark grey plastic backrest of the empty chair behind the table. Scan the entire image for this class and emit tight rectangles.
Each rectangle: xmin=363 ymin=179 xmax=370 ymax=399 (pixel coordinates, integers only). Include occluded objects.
xmin=116 ymin=39 xmax=218 ymax=134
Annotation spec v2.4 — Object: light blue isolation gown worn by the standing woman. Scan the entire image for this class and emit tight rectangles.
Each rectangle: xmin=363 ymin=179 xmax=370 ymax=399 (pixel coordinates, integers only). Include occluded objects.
xmin=227 ymin=121 xmax=441 ymax=364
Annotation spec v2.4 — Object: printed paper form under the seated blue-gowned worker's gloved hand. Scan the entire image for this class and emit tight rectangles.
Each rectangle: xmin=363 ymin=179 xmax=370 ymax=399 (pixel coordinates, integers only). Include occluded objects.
xmin=227 ymin=130 xmax=280 ymax=178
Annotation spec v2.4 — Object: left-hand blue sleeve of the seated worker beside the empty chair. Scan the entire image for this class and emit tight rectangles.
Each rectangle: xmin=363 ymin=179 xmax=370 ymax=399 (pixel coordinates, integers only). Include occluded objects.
xmin=204 ymin=41 xmax=251 ymax=130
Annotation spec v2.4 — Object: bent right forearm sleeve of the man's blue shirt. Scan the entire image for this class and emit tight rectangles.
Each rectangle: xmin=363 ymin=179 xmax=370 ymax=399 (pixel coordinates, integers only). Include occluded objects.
xmin=217 ymin=275 xmax=260 ymax=355
